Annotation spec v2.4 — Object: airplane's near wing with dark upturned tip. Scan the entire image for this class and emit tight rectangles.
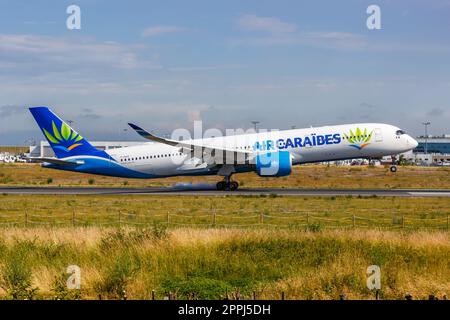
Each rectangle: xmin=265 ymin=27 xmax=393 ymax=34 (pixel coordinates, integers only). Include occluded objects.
xmin=128 ymin=123 xmax=254 ymax=163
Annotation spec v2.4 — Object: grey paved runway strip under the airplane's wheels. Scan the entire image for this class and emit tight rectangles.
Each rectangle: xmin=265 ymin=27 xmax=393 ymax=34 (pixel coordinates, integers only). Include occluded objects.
xmin=0 ymin=185 xmax=450 ymax=197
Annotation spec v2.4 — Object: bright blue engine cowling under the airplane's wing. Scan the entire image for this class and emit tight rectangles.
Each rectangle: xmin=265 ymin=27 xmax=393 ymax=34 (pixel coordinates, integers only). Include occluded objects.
xmin=256 ymin=151 xmax=292 ymax=177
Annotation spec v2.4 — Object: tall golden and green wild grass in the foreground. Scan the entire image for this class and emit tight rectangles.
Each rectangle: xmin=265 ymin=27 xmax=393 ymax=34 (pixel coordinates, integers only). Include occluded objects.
xmin=0 ymin=227 xmax=450 ymax=299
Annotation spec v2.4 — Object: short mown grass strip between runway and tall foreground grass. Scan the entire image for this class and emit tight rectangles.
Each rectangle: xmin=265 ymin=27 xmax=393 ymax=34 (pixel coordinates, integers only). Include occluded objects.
xmin=0 ymin=195 xmax=450 ymax=229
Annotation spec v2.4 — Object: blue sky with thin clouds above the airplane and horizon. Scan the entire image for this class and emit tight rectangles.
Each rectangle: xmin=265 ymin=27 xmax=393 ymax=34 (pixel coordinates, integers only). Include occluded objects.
xmin=0 ymin=0 xmax=450 ymax=145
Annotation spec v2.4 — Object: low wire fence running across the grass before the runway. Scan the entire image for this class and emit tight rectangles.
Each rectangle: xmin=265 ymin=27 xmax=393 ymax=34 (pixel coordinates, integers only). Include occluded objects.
xmin=0 ymin=209 xmax=450 ymax=230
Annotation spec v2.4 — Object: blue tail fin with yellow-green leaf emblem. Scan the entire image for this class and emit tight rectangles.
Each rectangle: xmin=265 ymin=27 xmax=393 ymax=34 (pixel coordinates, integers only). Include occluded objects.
xmin=30 ymin=107 xmax=108 ymax=158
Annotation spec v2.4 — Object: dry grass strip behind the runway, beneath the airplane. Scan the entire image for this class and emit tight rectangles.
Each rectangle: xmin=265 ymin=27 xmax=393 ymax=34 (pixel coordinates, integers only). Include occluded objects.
xmin=0 ymin=164 xmax=450 ymax=189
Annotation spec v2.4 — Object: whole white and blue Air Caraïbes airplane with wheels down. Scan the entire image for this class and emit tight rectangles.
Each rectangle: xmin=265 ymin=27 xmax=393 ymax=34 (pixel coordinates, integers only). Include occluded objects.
xmin=29 ymin=107 xmax=418 ymax=191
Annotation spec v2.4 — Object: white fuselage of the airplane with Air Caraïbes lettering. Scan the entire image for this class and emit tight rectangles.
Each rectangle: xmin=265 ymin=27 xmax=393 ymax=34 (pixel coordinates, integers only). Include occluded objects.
xmin=100 ymin=123 xmax=417 ymax=178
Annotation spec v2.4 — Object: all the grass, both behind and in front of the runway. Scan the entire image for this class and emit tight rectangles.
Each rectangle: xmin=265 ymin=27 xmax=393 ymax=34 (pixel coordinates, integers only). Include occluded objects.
xmin=0 ymin=165 xmax=450 ymax=299
